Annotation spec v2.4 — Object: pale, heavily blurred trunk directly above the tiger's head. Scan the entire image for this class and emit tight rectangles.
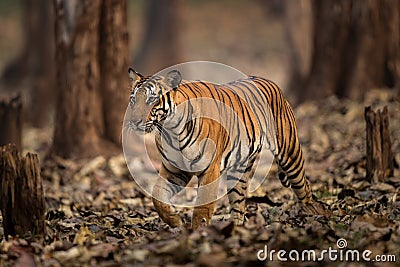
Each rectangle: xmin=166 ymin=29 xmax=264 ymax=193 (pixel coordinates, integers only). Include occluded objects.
xmin=133 ymin=0 xmax=185 ymax=75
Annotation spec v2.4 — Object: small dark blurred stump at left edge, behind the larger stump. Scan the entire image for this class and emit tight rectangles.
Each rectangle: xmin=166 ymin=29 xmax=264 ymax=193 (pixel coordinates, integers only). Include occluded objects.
xmin=0 ymin=95 xmax=22 ymax=151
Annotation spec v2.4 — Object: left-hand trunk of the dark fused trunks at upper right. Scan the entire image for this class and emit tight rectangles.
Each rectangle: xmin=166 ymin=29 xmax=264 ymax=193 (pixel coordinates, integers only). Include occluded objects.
xmin=299 ymin=0 xmax=351 ymax=99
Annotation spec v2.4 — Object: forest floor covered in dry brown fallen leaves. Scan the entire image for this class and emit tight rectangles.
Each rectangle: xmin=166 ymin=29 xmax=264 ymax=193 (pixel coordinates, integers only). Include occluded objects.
xmin=0 ymin=90 xmax=400 ymax=267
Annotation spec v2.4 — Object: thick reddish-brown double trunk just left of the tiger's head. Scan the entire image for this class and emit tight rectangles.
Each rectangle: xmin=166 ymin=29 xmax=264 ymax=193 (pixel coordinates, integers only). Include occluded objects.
xmin=52 ymin=0 xmax=129 ymax=157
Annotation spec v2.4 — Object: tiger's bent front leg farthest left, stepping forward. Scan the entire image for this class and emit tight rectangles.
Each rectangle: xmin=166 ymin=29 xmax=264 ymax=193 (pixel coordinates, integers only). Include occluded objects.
xmin=152 ymin=164 xmax=188 ymax=227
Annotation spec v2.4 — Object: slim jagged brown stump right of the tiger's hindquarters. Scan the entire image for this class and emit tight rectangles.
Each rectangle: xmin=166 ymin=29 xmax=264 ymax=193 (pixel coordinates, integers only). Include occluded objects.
xmin=364 ymin=106 xmax=394 ymax=183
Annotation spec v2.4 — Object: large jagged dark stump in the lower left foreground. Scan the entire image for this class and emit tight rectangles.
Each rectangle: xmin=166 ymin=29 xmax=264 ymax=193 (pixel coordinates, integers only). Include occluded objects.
xmin=0 ymin=145 xmax=45 ymax=238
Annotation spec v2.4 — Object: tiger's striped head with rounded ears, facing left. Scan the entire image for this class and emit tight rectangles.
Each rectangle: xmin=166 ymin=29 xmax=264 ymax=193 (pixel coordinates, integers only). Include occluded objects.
xmin=128 ymin=68 xmax=182 ymax=133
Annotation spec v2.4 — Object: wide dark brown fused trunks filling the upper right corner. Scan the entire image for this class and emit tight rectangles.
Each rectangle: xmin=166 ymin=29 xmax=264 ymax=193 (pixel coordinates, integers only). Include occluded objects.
xmin=289 ymin=0 xmax=400 ymax=100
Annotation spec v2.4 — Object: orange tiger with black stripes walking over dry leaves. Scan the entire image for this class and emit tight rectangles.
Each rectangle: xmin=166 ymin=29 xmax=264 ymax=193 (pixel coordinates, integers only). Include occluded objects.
xmin=128 ymin=68 xmax=313 ymax=229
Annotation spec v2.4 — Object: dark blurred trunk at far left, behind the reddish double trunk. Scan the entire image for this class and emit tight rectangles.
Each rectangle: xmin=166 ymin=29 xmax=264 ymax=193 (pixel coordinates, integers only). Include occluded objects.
xmin=1 ymin=0 xmax=56 ymax=127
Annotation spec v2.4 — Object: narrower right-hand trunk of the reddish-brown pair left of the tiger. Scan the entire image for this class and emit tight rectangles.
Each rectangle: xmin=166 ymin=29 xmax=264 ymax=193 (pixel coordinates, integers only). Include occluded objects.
xmin=99 ymin=0 xmax=129 ymax=144
